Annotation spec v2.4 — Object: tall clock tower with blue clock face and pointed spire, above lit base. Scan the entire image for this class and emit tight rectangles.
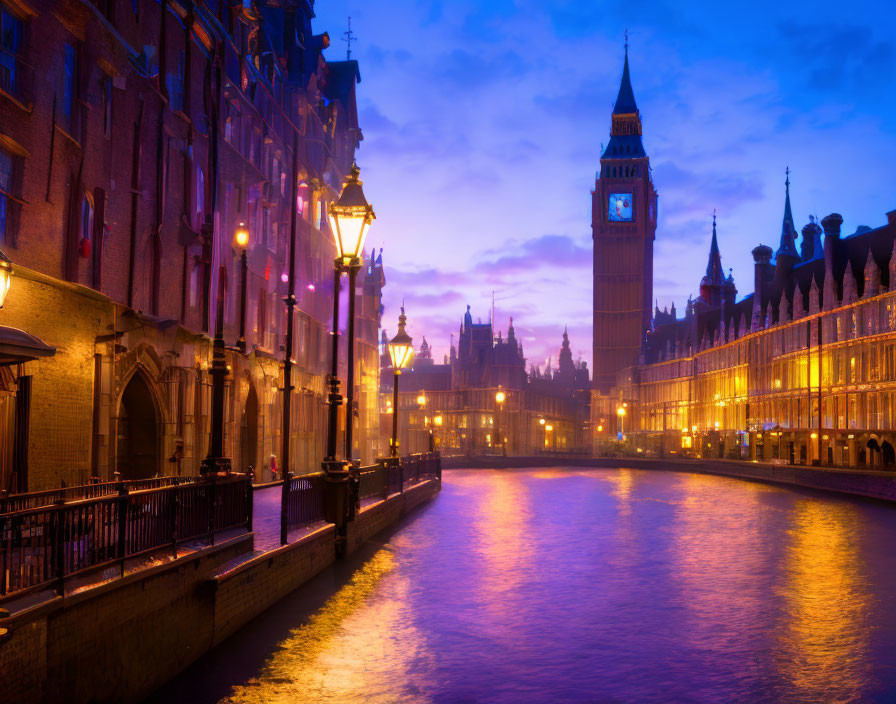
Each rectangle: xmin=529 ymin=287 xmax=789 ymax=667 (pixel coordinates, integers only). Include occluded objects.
xmin=591 ymin=42 xmax=657 ymax=393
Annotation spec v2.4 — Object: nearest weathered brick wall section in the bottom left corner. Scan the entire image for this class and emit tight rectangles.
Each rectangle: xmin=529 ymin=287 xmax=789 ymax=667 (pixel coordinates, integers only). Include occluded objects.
xmin=0 ymin=537 xmax=251 ymax=704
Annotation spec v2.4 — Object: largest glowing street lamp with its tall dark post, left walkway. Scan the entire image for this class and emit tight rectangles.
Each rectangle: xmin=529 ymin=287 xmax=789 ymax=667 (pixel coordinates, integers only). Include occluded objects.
xmin=328 ymin=164 xmax=376 ymax=461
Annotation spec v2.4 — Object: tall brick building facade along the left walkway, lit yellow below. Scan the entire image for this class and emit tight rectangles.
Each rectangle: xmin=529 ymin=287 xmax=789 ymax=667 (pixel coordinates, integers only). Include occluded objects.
xmin=0 ymin=0 xmax=384 ymax=490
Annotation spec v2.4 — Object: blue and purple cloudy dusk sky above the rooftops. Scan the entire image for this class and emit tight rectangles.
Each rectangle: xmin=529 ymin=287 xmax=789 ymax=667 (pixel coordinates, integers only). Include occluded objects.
xmin=314 ymin=0 xmax=896 ymax=367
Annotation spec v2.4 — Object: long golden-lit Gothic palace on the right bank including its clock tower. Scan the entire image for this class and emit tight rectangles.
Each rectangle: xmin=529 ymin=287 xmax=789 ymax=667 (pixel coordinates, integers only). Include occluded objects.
xmin=591 ymin=45 xmax=896 ymax=466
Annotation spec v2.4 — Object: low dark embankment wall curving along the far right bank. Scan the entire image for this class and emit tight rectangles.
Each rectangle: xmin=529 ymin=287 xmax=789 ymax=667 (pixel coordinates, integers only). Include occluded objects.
xmin=442 ymin=455 xmax=896 ymax=502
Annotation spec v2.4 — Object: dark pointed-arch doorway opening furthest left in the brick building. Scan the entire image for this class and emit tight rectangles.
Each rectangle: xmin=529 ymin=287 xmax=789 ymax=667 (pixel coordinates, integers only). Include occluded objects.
xmin=117 ymin=372 xmax=159 ymax=479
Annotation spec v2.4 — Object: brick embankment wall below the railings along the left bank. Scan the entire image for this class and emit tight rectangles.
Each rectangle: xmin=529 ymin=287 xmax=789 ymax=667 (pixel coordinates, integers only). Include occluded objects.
xmin=0 ymin=479 xmax=441 ymax=704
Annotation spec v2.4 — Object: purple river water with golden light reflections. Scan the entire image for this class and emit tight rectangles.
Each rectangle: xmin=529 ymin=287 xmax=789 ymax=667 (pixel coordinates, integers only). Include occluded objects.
xmin=158 ymin=469 xmax=896 ymax=704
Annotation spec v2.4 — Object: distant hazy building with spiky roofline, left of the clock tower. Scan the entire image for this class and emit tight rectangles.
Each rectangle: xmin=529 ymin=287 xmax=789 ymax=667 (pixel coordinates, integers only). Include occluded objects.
xmin=380 ymin=306 xmax=590 ymax=455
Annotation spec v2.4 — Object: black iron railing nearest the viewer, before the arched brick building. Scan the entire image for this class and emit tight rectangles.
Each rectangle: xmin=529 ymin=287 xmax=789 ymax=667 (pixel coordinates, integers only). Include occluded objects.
xmin=0 ymin=475 xmax=252 ymax=597
